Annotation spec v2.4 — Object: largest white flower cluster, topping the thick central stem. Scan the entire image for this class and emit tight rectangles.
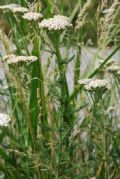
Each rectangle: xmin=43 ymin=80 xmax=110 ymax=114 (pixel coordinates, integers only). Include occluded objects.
xmin=39 ymin=15 xmax=72 ymax=30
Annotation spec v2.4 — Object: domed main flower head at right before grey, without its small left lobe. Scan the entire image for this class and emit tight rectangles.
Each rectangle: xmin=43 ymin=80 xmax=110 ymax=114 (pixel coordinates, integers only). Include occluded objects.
xmin=85 ymin=79 xmax=110 ymax=92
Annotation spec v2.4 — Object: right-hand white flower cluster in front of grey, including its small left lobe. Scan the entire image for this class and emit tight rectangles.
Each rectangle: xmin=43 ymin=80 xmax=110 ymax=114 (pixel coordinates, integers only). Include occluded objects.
xmin=79 ymin=79 xmax=110 ymax=91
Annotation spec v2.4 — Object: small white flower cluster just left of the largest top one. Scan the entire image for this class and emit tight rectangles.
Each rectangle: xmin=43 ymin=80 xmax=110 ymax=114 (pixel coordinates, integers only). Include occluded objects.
xmin=22 ymin=12 xmax=43 ymax=21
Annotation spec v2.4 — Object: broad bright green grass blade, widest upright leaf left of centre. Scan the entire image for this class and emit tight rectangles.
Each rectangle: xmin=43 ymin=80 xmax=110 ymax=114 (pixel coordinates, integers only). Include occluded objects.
xmin=30 ymin=28 xmax=47 ymax=140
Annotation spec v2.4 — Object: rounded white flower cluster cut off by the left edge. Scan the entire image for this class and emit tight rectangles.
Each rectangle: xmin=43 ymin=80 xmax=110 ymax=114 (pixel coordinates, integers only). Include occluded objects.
xmin=0 ymin=113 xmax=11 ymax=127
